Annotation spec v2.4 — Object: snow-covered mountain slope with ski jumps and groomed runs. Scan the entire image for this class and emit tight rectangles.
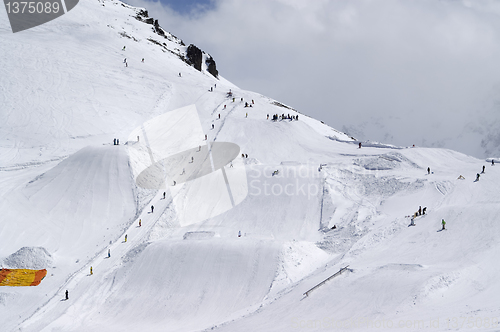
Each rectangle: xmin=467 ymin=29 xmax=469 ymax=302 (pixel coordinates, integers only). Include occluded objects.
xmin=0 ymin=0 xmax=500 ymax=331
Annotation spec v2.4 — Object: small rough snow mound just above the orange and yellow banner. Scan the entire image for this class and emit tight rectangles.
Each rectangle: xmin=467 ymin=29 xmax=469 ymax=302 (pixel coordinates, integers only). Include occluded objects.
xmin=2 ymin=247 xmax=52 ymax=270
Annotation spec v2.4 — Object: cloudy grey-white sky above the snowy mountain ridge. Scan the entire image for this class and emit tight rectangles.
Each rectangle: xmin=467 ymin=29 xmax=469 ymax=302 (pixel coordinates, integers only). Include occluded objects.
xmin=126 ymin=0 xmax=500 ymax=157
